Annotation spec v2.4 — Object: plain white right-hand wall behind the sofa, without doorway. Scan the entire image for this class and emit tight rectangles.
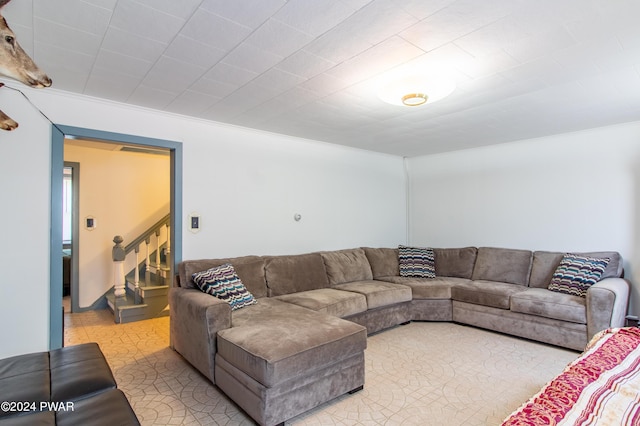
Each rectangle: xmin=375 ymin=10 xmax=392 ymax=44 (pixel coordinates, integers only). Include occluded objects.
xmin=408 ymin=122 xmax=640 ymax=314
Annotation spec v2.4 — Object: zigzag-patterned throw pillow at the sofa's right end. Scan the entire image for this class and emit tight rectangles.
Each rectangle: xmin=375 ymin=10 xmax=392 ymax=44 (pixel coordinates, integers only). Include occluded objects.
xmin=549 ymin=254 xmax=609 ymax=297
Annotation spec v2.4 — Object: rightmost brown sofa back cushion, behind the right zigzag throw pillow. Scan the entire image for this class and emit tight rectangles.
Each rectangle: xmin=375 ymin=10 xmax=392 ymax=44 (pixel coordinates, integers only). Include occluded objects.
xmin=529 ymin=251 xmax=622 ymax=288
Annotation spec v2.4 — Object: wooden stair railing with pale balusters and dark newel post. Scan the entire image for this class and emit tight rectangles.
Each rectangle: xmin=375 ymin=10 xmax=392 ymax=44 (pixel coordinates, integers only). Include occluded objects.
xmin=112 ymin=214 xmax=171 ymax=304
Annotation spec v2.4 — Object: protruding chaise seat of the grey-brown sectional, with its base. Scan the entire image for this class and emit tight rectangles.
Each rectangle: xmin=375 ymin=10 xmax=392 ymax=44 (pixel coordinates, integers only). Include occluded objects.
xmin=215 ymin=298 xmax=367 ymax=425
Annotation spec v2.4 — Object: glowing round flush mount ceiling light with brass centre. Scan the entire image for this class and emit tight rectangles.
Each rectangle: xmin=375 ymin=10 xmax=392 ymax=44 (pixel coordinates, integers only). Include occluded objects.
xmin=378 ymin=72 xmax=456 ymax=107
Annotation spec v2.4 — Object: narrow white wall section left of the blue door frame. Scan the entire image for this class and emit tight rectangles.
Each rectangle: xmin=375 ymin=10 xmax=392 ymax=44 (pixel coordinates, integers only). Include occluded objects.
xmin=0 ymin=88 xmax=51 ymax=358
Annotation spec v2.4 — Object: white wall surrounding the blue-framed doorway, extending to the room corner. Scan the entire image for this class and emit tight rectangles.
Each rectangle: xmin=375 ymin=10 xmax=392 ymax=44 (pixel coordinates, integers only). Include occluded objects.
xmin=0 ymin=88 xmax=406 ymax=358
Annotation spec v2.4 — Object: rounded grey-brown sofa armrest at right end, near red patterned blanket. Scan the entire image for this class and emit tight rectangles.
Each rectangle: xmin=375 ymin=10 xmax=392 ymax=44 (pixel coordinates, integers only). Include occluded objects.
xmin=587 ymin=278 xmax=629 ymax=340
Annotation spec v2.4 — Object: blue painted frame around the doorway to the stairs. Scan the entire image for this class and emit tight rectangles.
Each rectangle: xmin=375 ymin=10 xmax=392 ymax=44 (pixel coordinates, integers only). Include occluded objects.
xmin=49 ymin=124 xmax=182 ymax=349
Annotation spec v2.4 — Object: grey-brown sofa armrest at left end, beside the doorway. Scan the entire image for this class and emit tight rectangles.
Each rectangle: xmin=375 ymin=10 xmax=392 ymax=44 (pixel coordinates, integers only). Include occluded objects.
xmin=169 ymin=287 xmax=231 ymax=384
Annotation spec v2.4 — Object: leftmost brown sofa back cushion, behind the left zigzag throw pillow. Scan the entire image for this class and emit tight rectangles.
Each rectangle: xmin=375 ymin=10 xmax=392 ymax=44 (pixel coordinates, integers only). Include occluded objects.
xmin=177 ymin=256 xmax=267 ymax=298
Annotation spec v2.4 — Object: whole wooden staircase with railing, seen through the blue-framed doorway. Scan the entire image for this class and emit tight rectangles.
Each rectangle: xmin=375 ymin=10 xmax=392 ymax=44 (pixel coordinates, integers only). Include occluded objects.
xmin=106 ymin=215 xmax=172 ymax=324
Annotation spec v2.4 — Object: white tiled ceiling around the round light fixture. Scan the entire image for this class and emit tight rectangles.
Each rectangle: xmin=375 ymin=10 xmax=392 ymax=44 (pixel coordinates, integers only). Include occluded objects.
xmin=3 ymin=0 xmax=640 ymax=156
